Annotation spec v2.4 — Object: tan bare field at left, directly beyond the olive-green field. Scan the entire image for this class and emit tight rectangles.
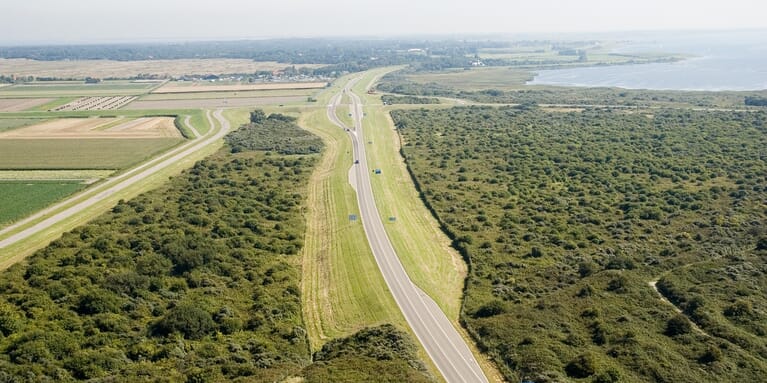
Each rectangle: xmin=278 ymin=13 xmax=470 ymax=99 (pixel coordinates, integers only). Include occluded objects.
xmin=0 ymin=117 xmax=181 ymax=139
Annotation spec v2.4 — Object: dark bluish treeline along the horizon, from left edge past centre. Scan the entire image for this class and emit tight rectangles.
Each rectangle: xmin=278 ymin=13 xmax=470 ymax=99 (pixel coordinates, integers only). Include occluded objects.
xmin=0 ymin=39 xmax=507 ymax=74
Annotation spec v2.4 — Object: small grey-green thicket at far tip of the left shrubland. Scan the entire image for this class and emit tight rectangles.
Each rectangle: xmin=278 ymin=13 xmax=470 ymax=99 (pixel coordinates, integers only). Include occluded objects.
xmin=225 ymin=110 xmax=322 ymax=154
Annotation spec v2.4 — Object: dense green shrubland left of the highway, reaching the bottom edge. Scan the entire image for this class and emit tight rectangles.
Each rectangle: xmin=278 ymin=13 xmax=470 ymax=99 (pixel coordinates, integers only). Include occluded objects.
xmin=0 ymin=109 xmax=430 ymax=382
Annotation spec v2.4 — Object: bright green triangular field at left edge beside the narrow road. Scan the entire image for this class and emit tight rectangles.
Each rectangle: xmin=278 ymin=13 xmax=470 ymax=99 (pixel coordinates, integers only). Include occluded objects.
xmin=0 ymin=181 xmax=85 ymax=226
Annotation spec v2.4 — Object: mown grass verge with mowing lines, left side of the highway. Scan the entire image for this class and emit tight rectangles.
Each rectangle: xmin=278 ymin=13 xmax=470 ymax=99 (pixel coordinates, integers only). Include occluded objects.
xmin=299 ymin=104 xmax=407 ymax=350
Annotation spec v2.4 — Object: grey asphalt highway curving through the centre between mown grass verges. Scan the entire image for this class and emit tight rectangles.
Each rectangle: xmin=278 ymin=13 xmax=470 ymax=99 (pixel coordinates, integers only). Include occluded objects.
xmin=327 ymin=79 xmax=487 ymax=383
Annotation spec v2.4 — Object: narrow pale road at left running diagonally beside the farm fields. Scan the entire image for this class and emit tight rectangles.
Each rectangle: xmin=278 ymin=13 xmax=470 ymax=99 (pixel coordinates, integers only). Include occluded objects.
xmin=0 ymin=109 xmax=231 ymax=254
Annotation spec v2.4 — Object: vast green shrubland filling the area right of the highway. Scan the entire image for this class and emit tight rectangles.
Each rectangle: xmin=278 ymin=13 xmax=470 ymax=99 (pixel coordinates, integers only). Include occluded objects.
xmin=391 ymin=106 xmax=767 ymax=382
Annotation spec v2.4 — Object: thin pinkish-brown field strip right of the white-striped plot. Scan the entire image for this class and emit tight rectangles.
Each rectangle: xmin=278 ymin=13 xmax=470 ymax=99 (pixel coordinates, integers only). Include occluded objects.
xmin=123 ymin=96 xmax=306 ymax=110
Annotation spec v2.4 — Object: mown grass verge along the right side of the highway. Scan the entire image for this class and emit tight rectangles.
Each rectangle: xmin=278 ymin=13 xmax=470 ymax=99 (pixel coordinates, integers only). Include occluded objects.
xmin=354 ymin=70 xmax=466 ymax=321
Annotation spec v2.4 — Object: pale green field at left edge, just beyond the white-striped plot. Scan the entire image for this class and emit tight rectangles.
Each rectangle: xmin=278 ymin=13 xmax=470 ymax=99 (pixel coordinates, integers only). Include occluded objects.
xmin=0 ymin=81 xmax=157 ymax=97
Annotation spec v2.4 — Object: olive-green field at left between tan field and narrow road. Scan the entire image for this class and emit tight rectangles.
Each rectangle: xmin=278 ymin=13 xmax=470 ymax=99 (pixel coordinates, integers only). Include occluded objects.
xmin=0 ymin=138 xmax=183 ymax=170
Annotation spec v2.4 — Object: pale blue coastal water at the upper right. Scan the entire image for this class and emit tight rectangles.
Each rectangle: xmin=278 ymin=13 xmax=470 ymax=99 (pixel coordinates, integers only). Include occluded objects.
xmin=528 ymin=31 xmax=767 ymax=90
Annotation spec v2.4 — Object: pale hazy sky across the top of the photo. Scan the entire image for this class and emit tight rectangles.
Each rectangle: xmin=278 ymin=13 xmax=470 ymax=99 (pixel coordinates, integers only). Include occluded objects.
xmin=0 ymin=0 xmax=767 ymax=44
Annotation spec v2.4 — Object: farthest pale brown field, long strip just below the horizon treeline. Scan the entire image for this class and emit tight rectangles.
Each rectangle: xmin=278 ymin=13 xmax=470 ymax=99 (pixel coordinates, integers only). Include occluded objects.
xmin=0 ymin=59 xmax=322 ymax=79
